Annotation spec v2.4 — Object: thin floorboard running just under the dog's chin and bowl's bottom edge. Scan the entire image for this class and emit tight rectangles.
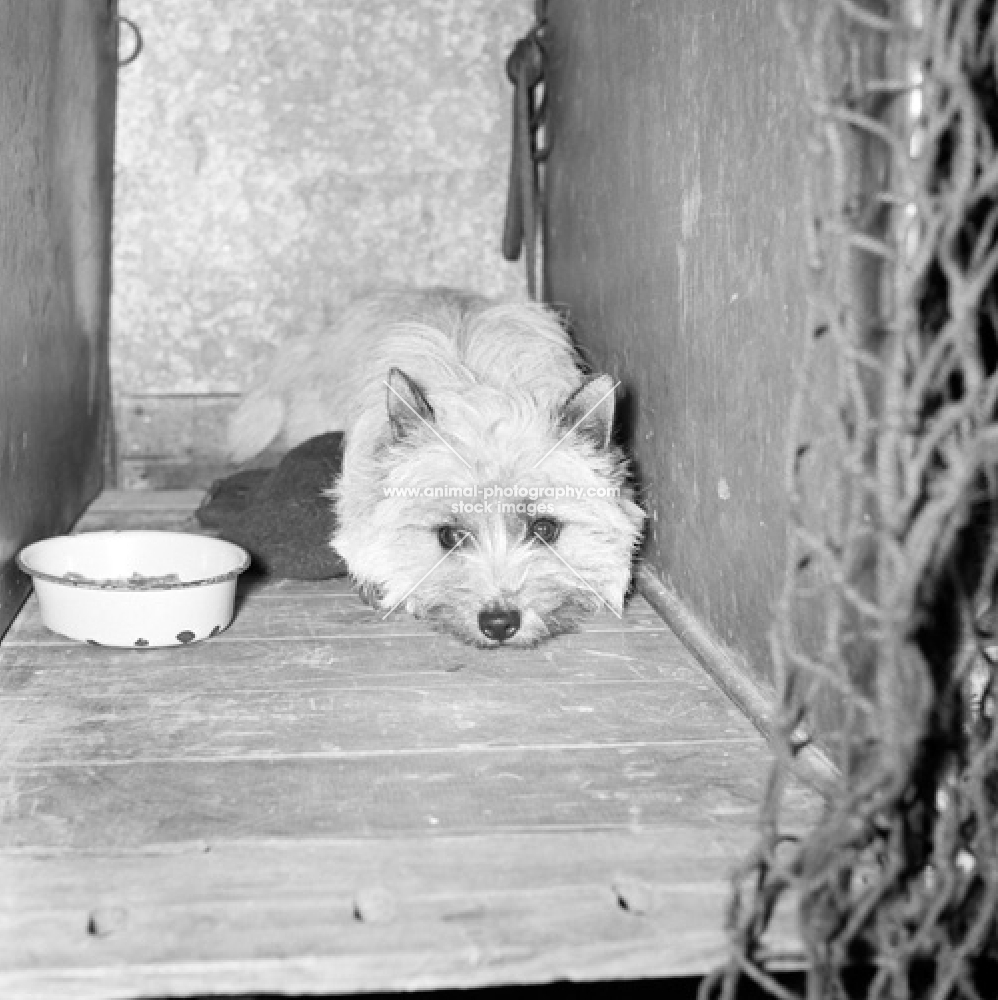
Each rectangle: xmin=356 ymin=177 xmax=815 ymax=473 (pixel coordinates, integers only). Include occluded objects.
xmin=0 ymin=633 xmax=724 ymax=712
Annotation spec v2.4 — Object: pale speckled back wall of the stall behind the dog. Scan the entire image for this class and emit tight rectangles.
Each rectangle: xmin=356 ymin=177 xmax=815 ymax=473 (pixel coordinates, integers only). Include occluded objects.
xmin=112 ymin=0 xmax=533 ymax=485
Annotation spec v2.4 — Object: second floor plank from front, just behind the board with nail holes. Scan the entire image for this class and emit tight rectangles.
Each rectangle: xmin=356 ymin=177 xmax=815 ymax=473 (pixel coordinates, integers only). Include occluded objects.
xmin=0 ymin=744 xmax=809 ymax=848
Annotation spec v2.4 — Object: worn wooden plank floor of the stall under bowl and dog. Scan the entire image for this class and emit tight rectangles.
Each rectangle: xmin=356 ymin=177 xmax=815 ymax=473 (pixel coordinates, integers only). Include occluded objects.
xmin=0 ymin=492 xmax=813 ymax=1000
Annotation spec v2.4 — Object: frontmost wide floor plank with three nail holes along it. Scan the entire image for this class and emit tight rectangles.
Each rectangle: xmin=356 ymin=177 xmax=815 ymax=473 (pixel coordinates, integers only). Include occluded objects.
xmin=0 ymin=827 xmax=804 ymax=1000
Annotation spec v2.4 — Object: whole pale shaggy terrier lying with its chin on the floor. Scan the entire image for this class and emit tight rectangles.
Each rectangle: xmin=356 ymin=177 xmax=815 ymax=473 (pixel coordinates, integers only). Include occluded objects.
xmin=229 ymin=289 xmax=644 ymax=646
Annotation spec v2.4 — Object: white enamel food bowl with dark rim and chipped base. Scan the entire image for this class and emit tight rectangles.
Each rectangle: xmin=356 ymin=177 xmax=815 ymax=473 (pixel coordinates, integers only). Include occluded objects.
xmin=17 ymin=531 xmax=250 ymax=649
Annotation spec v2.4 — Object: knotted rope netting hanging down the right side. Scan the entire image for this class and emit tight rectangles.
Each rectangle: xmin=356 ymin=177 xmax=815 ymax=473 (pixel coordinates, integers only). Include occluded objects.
xmin=702 ymin=0 xmax=998 ymax=1000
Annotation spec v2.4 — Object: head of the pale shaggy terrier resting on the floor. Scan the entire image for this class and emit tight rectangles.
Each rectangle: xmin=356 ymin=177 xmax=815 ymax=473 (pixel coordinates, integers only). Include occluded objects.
xmin=333 ymin=369 xmax=644 ymax=646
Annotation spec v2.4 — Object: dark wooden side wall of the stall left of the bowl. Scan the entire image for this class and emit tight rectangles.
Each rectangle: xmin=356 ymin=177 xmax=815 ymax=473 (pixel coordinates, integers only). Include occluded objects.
xmin=0 ymin=0 xmax=117 ymax=634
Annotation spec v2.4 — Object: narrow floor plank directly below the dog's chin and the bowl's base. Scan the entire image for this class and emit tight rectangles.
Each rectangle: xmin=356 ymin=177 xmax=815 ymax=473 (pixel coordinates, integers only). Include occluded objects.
xmin=0 ymin=623 xmax=720 ymax=688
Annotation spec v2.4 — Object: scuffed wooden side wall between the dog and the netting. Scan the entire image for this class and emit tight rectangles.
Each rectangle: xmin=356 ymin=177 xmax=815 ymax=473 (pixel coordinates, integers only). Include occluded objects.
xmin=546 ymin=0 xmax=820 ymax=688
